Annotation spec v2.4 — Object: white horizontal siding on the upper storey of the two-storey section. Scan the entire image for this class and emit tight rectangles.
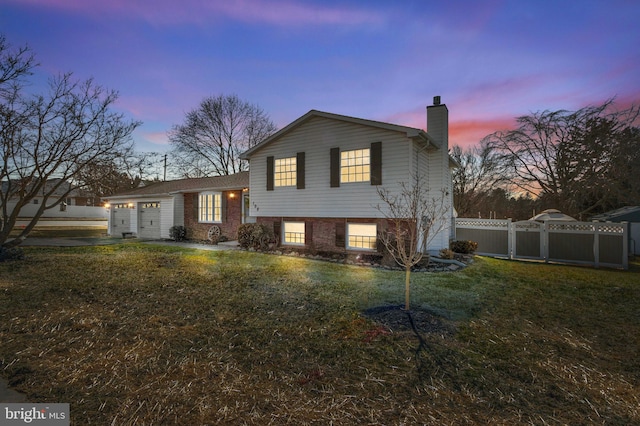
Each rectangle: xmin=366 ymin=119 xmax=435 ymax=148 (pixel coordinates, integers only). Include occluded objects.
xmin=249 ymin=117 xmax=412 ymax=218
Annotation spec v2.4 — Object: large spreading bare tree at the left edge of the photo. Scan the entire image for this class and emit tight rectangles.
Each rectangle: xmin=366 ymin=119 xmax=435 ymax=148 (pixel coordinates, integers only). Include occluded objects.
xmin=0 ymin=38 xmax=139 ymax=247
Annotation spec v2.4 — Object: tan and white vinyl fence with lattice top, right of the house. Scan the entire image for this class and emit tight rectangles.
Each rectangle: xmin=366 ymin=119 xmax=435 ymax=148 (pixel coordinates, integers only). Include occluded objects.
xmin=456 ymin=218 xmax=629 ymax=269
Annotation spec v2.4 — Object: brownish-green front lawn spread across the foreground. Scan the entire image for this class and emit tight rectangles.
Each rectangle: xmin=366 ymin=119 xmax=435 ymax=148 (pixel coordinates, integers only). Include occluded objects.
xmin=0 ymin=243 xmax=640 ymax=425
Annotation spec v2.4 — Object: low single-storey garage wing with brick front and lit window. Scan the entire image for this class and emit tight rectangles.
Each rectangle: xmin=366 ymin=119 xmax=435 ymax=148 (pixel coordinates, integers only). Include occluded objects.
xmin=107 ymin=172 xmax=252 ymax=240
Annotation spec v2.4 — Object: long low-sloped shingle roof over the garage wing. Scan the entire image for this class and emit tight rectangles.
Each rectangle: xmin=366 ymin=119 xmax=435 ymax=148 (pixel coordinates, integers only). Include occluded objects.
xmin=107 ymin=172 xmax=249 ymax=198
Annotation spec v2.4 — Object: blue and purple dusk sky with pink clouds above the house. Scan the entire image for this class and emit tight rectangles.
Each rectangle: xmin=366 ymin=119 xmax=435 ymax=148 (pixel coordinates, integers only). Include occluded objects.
xmin=0 ymin=0 xmax=640 ymax=151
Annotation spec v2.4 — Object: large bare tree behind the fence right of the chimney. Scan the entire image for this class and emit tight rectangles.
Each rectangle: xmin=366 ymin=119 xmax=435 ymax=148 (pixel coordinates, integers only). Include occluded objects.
xmin=486 ymin=100 xmax=640 ymax=214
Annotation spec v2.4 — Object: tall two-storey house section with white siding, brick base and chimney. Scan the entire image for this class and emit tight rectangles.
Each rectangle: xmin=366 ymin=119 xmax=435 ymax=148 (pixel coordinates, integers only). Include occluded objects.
xmin=241 ymin=96 xmax=454 ymax=253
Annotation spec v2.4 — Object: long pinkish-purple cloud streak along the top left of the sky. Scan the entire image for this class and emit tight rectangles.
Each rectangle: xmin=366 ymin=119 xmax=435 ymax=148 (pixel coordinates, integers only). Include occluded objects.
xmin=9 ymin=0 xmax=384 ymax=26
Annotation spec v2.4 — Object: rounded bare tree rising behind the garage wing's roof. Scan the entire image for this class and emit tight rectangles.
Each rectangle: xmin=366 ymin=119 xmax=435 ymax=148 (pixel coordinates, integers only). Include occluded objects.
xmin=169 ymin=95 xmax=276 ymax=177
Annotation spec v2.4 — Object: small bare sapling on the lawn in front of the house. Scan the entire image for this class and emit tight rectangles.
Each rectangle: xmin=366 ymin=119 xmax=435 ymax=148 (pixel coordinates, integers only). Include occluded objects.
xmin=377 ymin=177 xmax=451 ymax=310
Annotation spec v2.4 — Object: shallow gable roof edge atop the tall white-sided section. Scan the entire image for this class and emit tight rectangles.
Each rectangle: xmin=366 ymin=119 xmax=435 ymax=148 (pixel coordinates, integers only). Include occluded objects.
xmin=240 ymin=109 xmax=440 ymax=160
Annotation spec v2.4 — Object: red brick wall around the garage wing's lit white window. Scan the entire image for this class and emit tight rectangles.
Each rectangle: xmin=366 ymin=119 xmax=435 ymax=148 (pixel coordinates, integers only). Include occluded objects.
xmin=184 ymin=190 xmax=242 ymax=240
